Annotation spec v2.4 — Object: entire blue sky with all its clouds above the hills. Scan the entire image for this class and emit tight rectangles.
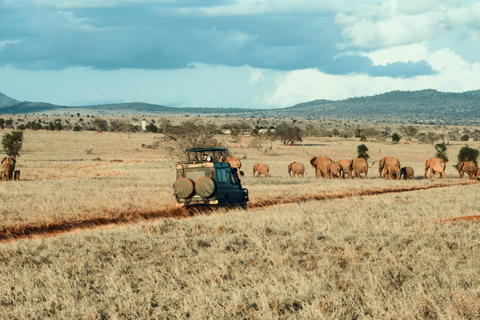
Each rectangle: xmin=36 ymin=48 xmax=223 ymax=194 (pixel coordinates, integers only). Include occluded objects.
xmin=0 ymin=0 xmax=480 ymax=108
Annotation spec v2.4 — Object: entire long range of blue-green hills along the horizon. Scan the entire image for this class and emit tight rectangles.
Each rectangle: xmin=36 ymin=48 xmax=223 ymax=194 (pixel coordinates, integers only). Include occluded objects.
xmin=0 ymin=89 xmax=480 ymax=125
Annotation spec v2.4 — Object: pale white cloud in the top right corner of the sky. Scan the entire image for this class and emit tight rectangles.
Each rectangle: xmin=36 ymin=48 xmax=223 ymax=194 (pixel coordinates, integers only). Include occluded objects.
xmin=335 ymin=0 xmax=480 ymax=48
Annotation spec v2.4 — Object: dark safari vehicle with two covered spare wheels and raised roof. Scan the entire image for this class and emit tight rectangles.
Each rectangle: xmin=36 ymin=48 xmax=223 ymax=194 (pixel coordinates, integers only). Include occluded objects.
xmin=173 ymin=148 xmax=249 ymax=209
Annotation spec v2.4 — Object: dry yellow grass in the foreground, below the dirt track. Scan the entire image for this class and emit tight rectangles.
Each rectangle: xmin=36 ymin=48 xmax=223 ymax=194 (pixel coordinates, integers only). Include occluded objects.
xmin=0 ymin=186 xmax=480 ymax=319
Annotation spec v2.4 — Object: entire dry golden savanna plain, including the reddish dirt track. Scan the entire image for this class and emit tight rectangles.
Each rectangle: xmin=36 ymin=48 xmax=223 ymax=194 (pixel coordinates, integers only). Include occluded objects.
xmin=0 ymin=119 xmax=480 ymax=319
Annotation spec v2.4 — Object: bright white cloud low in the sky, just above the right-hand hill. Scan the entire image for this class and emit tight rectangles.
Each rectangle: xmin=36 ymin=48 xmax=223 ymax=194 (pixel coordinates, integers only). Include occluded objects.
xmin=257 ymin=43 xmax=480 ymax=107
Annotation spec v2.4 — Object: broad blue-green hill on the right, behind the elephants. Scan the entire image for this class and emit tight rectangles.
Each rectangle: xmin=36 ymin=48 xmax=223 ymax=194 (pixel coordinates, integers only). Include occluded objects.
xmin=260 ymin=90 xmax=480 ymax=124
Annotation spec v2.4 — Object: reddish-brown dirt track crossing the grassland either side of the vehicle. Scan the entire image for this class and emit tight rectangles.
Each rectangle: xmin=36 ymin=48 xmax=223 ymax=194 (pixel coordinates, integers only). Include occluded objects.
xmin=0 ymin=181 xmax=480 ymax=243
